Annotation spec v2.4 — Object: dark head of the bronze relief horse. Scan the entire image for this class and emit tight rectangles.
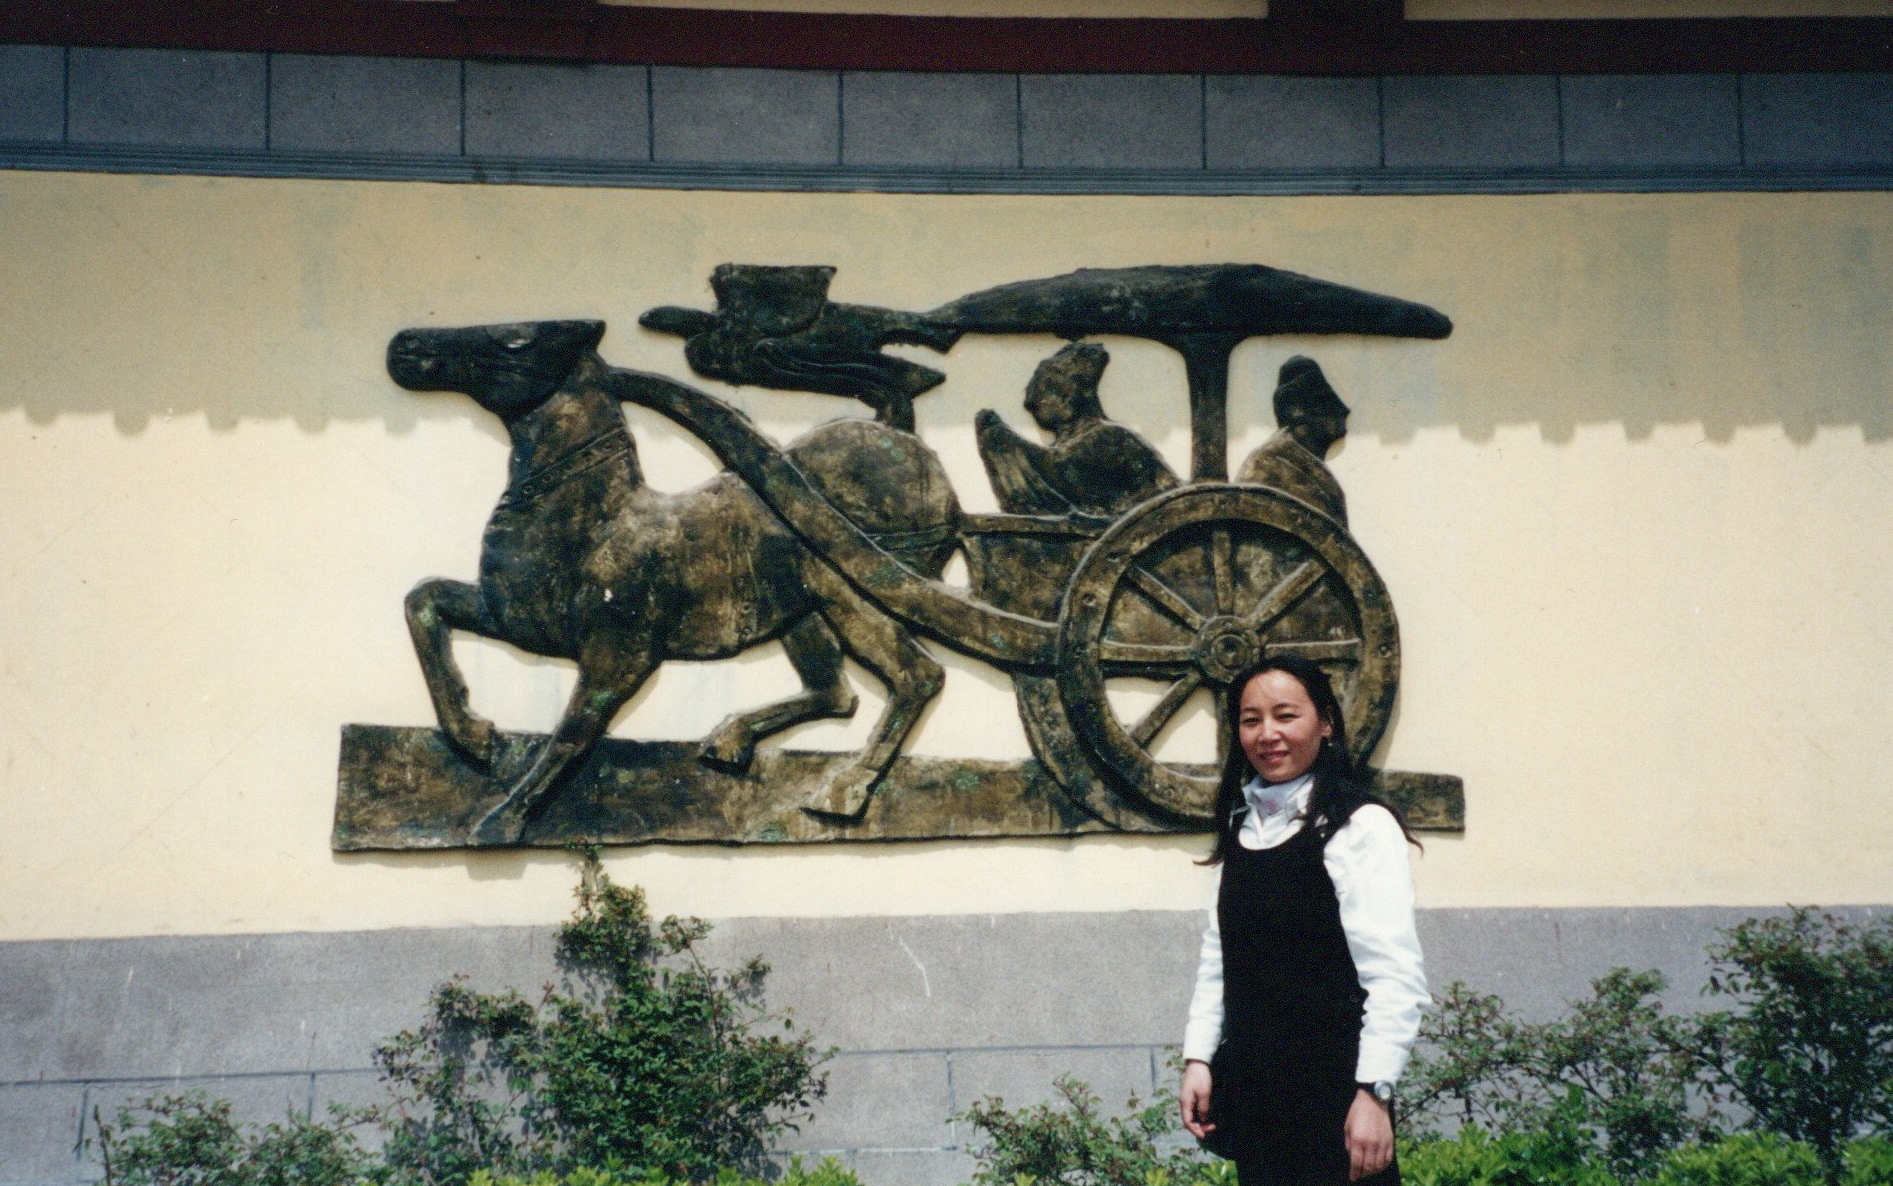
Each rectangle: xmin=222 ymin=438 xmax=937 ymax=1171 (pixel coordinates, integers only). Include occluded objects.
xmin=388 ymin=322 xmax=604 ymax=422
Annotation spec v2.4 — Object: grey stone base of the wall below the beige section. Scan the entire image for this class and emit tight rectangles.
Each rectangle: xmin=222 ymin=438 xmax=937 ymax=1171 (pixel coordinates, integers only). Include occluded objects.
xmin=0 ymin=906 xmax=1889 ymax=1186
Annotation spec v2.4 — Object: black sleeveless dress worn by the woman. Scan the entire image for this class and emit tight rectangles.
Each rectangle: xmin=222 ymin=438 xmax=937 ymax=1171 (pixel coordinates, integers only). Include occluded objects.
xmin=1210 ymin=798 xmax=1401 ymax=1186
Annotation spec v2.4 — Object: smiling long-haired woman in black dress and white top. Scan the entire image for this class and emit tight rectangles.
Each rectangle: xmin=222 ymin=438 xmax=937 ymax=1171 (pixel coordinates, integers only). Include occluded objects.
xmin=1181 ymin=654 xmax=1427 ymax=1186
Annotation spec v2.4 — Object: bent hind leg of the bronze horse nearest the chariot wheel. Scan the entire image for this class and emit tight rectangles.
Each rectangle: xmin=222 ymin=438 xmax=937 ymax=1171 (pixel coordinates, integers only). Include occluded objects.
xmin=803 ymin=562 xmax=947 ymax=819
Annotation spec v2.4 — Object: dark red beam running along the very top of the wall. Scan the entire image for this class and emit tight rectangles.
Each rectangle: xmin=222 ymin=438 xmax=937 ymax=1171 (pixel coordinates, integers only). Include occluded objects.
xmin=0 ymin=0 xmax=1893 ymax=74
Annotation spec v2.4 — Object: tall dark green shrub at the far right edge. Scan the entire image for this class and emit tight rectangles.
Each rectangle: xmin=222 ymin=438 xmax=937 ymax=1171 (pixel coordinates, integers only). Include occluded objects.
xmin=1702 ymin=910 xmax=1893 ymax=1186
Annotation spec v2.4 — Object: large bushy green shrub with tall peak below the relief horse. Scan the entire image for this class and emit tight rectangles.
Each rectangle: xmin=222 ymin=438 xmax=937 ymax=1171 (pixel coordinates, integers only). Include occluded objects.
xmin=377 ymin=855 xmax=827 ymax=1186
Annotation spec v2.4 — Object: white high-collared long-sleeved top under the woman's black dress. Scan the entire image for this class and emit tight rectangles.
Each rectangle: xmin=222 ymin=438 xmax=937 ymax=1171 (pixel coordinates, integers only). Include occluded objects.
xmin=1183 ymin=774 xmax=1427 ymax=1084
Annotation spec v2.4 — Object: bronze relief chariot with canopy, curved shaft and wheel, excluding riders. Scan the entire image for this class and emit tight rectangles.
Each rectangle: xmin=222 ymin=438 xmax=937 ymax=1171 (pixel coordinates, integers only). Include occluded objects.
xmin=623 ymin=265 xmax=1450 ymax=827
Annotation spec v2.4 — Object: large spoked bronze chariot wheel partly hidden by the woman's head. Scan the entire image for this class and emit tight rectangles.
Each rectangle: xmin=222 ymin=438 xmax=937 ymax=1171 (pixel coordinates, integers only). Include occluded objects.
xmin=1044 ymin=482 xmax=1399 ymax=828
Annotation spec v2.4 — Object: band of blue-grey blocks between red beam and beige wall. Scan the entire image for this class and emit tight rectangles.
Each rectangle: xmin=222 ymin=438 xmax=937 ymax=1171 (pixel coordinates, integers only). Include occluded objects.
xmin=0 ymin=45 xmax=1893 ymax=191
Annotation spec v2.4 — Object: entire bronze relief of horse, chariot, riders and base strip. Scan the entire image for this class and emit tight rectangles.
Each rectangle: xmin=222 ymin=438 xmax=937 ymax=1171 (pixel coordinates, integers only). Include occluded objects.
xmin=335 ymin=265 xmax=1463 ymax=849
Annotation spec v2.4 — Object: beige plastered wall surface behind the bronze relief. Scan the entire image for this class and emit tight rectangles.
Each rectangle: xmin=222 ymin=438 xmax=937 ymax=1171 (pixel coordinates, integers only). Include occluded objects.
xmin=0 ymin=172 xmax=1893 ymax=938
